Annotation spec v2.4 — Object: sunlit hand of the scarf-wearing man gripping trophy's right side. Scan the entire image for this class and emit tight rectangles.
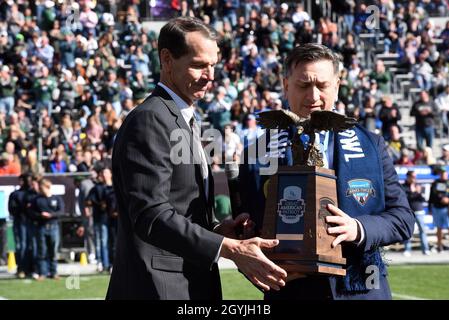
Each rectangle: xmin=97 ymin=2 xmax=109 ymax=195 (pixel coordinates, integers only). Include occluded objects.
xmin=326 ymin=204 xmax=360 ymax=248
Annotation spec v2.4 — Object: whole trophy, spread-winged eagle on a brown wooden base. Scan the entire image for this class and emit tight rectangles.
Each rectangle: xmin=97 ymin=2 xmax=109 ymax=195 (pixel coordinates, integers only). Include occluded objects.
xmin=258 ymin=110 xmax=356 ymax=276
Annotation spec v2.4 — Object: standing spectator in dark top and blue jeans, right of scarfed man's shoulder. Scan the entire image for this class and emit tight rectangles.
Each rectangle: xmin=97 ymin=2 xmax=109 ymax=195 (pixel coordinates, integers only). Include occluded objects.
xmin=410 ymin=91 xmax=437 ymax=150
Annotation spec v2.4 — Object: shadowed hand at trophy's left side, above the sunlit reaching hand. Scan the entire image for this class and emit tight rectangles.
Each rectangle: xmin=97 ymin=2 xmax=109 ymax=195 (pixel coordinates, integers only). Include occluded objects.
xmin=214 ymin=213 xmax=255 ymax=239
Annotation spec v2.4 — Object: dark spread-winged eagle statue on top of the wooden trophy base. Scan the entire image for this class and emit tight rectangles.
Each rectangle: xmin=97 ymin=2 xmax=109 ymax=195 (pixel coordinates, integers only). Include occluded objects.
xmin=258 ymin=109 xmax=357 ymax=167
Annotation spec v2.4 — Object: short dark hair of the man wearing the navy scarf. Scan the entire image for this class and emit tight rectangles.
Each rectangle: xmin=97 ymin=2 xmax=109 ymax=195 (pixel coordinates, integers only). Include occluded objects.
xmin=284 ymin=43 xmax=342 ymax=77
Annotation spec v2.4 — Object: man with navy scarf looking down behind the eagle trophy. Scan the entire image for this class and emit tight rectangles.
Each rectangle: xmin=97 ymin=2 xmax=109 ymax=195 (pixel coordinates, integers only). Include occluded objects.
xmin=239 ymin=44 xmax=414 ymax=300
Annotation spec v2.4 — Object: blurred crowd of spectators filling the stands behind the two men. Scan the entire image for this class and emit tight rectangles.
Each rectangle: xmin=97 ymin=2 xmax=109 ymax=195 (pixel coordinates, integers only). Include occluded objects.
xmin=0 ymin=0 xmax=449 ymax=175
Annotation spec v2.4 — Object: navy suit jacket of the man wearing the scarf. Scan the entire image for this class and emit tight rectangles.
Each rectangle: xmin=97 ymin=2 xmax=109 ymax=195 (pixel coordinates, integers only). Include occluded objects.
xmin=239 ymin=126 xmax=415 ymax=300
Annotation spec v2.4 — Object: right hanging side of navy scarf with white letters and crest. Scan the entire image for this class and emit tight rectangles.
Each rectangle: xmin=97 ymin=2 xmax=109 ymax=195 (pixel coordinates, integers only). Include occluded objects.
xmin=334 ymin=126 xmax=385 ymax=293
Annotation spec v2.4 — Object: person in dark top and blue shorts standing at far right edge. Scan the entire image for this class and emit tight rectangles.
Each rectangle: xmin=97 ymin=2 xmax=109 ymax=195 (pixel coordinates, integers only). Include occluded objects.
xmin=429 ymin=167 xmax=449 ymax=252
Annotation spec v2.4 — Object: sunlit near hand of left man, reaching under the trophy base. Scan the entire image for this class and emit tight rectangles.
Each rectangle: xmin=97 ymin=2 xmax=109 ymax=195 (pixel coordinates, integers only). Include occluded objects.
xmin=220 ymin=237 xmax=287 ymax=291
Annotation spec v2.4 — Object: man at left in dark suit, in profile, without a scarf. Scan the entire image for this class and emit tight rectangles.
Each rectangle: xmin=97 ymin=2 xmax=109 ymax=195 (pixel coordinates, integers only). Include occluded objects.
xmin=107 ymin=18 xmax=287 ymax=299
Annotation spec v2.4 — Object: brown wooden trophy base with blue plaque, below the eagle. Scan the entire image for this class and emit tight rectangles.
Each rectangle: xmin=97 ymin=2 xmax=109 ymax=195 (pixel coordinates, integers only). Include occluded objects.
xmin=262 ymin=166 xmax=346 ymax=276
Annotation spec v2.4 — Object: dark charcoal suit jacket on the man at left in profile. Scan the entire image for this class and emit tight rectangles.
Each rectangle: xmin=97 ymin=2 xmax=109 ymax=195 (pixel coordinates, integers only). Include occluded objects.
xmin=107 ymin=87 xmax=223 ymax=299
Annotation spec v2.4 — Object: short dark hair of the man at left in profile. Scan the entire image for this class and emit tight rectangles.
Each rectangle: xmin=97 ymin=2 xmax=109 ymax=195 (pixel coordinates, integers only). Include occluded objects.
xmin=158 ymin=17 xmax=218 ymax=59
